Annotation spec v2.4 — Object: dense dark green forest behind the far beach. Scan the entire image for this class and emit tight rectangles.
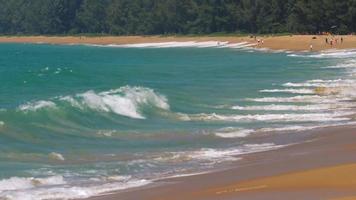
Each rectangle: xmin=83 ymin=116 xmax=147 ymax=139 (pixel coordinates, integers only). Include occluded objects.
xmin=0 ymin=0 xmax=356 ymax=35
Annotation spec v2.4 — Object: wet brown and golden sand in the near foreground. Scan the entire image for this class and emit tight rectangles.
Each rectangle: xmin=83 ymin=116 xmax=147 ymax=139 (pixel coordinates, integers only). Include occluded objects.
xmin=88 ymin=126 xmax=356 ymax=200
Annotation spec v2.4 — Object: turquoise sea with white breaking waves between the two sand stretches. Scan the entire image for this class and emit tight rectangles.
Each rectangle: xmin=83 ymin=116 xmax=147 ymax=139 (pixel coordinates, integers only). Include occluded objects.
xmin=0 ymin=44 xmax=356 ymax=199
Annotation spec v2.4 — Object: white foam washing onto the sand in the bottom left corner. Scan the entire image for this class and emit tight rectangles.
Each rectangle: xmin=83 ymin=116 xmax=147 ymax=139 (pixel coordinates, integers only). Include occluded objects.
xmin=0 ymin=176 xmax=150 ymax=200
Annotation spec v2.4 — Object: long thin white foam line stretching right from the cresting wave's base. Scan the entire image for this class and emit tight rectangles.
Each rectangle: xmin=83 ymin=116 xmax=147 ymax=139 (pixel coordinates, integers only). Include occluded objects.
xmin=180 ymin=112 xmax=354 ymax=122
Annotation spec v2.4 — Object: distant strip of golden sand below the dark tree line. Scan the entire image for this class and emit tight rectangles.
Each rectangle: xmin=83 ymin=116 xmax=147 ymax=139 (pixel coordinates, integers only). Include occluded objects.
xmin=0 ymin=35 xmax=356 ymax=51
